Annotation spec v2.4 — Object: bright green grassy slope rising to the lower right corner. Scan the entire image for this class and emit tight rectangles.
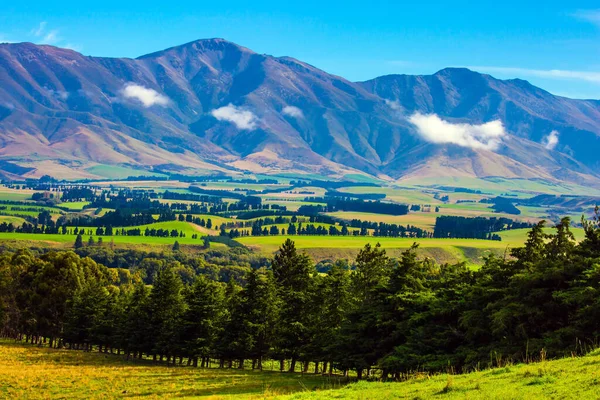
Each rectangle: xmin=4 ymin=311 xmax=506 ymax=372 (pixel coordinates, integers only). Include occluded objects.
xmin=284 ymin=353 xmax=600 ymax=400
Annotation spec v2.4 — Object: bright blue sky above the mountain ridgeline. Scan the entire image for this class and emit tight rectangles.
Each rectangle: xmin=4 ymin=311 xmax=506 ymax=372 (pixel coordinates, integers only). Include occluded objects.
xmin=0 ymin=0 xmax=600 ymax=99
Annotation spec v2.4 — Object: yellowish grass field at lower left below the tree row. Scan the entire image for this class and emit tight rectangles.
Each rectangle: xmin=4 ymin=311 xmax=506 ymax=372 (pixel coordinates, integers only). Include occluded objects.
xmin=0 ymin=341 xmax=339 ymax=399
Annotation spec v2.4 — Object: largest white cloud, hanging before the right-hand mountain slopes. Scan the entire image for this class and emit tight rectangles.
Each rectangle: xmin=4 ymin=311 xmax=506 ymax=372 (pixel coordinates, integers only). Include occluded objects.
xmin=408 ymin=112 xmax=506 ymax=150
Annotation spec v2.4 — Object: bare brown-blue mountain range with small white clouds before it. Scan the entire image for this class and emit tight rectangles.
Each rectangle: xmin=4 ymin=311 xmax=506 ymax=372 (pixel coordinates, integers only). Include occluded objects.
xmin=0 ymin=39 xmax=600 ymax=187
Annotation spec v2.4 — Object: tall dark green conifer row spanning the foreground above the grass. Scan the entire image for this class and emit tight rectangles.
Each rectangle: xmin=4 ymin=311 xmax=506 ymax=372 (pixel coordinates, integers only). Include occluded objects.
xmin=0 ymin=214 xmax=600 ymax=379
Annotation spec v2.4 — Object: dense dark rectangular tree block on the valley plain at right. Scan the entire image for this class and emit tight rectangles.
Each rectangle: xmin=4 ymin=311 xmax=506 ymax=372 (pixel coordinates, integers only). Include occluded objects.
xmin=433 ymin=215 xmax=533 ymax=240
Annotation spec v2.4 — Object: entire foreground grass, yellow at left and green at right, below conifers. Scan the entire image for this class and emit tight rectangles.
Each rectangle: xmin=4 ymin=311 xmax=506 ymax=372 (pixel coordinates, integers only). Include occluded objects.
xmin=0 ymin=340 xmax=600 ymax=400
